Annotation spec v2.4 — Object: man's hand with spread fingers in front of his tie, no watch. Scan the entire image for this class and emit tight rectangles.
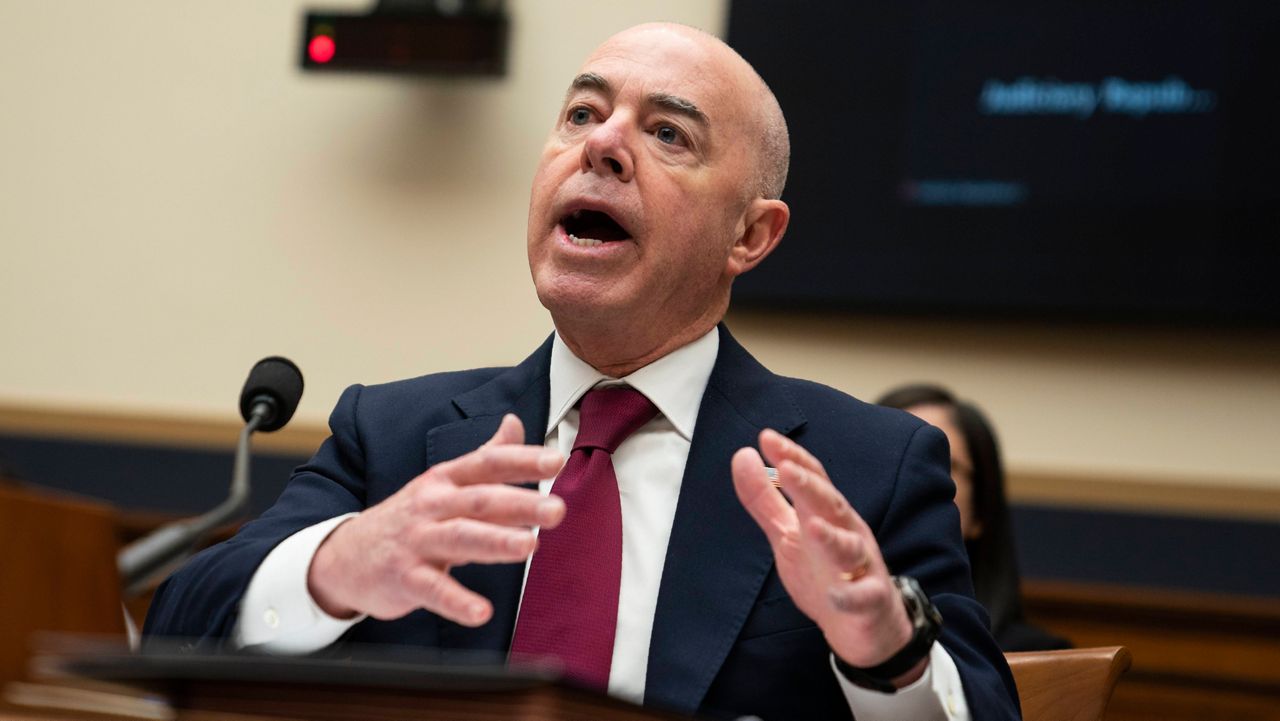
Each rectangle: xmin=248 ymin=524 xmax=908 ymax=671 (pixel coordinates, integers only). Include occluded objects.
xmin=307 ymin=414 xmax=564 ymax=626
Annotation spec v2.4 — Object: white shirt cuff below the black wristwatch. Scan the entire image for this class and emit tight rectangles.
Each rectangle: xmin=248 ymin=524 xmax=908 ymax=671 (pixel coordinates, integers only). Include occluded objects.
xmin=831 ymin=642 xmax=970 ymax=721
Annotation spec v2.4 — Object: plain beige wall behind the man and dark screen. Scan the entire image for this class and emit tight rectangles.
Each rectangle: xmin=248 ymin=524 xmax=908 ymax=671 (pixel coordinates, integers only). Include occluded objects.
xmin=0 ymin=0 xmax=1280 ymax=488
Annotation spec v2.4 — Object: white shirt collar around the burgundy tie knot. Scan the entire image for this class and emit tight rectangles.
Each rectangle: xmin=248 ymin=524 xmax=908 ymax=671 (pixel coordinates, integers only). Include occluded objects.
xmin=547 ymin=328 xmax=719 ymax=441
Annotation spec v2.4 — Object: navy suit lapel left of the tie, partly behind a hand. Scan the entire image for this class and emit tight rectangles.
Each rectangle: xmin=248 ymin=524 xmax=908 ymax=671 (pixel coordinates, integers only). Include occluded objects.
xmin=426 ymin=338 xmax=552 ymax=653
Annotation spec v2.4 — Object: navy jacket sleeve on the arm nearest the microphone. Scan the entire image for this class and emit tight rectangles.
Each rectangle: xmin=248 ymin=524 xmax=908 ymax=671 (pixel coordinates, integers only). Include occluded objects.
xmin=143 ymin=385 xmax=366 ymax=649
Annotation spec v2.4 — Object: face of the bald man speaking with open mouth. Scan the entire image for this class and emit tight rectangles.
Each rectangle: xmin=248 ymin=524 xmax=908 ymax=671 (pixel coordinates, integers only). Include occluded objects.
xmin=529 ymin=27 xmax=755 ymax=345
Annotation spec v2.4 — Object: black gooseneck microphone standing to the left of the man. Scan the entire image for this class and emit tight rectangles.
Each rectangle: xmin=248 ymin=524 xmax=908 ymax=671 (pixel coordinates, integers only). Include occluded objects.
xmin=115 ymin=356 xmax=302 ymax=595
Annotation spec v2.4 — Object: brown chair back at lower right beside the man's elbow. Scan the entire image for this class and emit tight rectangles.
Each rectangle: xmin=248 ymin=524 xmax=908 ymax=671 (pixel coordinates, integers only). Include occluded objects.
xmin=1005 ymin=645 xmax=1132 ymax=721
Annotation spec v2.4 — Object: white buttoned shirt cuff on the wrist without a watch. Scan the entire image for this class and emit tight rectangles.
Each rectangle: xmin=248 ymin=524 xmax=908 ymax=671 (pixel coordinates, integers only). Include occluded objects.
xmin=233 ymin=514 xmax=365 ymax=654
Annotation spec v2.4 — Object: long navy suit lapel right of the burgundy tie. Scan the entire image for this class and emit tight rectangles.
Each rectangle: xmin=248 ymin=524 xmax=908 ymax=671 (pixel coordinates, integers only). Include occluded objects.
xmin=645 ymin=325 xmax=805 ymax=712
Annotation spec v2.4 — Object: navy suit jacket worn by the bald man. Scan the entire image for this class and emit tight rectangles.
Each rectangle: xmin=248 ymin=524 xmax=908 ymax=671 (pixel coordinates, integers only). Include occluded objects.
xmin=145 ymin=325 xmax=1019 ymax=721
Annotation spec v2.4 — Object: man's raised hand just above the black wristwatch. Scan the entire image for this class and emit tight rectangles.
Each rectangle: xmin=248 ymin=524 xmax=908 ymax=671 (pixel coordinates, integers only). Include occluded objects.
xmin=732 ymin=430 xmax=928 ymax=688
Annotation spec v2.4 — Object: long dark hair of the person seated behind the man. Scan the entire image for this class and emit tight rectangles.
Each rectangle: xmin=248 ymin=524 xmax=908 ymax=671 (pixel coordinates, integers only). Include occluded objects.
xmin=878 ymin=383 xmax=1023 ymax=638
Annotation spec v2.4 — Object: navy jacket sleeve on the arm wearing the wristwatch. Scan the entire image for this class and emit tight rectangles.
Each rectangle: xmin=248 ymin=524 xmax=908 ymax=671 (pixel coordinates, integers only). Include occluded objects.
xmin=876 ymin=425 xmax=1020 ymax=720
